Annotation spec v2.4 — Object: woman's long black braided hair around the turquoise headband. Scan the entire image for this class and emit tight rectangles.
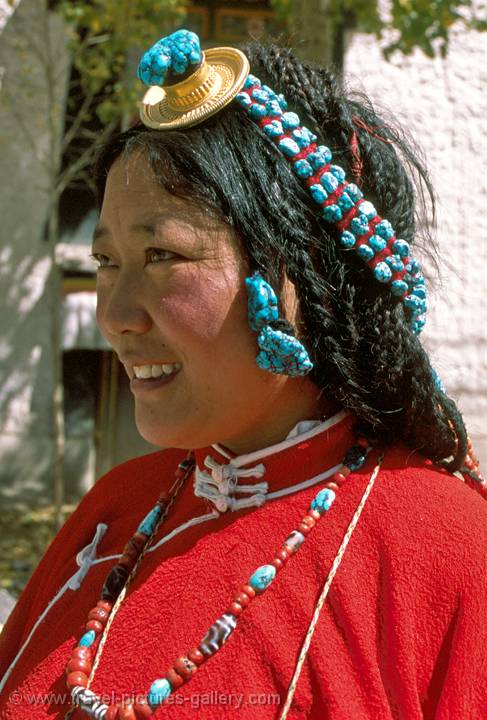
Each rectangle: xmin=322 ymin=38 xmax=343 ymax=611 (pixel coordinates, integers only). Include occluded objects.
xmin=96 ymin=43 xmax=480 ymax=478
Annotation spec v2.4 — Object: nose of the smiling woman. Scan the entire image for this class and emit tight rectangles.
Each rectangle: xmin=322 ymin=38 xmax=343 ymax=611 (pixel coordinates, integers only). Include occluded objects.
xmin=96 ymin=272 xmax=152 ymax=336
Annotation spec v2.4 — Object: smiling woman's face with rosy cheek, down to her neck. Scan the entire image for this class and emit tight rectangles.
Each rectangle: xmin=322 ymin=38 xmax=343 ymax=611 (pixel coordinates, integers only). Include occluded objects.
xmin=93 ymin=153 xmax=326 ymax=452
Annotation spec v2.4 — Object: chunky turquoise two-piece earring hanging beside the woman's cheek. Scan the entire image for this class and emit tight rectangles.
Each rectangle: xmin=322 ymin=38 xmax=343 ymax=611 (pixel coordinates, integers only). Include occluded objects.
xmin=245 ymin=272 xmax=313 ymax=377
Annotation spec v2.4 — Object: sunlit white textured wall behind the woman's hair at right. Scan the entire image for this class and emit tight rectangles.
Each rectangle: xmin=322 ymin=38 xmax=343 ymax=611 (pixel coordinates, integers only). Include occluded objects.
xmin=345 ymin=28 xmax=487 ymax=474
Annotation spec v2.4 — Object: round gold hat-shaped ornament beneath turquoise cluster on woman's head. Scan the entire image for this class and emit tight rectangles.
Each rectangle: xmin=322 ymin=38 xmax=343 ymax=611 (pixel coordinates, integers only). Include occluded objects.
xmin=140 ymin=47 xmax=250 ymax=130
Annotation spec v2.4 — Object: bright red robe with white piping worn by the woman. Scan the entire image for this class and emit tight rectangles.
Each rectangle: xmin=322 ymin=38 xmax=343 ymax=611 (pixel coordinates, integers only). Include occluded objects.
xmin=0 ymin=418 xmax=487 ymax=720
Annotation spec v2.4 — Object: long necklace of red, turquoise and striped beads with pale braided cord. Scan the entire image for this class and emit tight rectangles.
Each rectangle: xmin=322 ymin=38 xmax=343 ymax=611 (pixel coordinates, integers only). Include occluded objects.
xmin=65 ymin=438 xmax=382 ymax=720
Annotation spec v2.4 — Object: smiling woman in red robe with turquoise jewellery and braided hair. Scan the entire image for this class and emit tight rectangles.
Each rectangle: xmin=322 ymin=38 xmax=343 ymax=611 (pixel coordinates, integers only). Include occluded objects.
xmin=0 ymin=31 xmax=487 ymax=720
